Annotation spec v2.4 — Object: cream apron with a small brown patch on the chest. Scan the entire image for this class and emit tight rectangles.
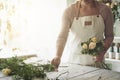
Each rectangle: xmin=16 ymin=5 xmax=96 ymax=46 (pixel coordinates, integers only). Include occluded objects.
xmin=69 ymin=15 xmax=105 ymax=65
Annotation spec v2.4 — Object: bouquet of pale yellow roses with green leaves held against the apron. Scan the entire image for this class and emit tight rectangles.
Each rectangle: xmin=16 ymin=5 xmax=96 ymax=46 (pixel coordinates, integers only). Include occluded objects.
xmin=81 ymin=37 xmax=104 ymax=56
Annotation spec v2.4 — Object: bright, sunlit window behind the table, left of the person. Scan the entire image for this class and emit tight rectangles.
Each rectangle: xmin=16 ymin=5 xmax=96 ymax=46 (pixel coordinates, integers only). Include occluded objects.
xmin=0 ymin=0 xmax=66 ymax=58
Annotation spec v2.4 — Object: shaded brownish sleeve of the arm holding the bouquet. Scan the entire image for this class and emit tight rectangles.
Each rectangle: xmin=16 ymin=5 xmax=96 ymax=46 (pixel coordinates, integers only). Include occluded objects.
xmin=102 ymin=6 xmax=114 ymax=52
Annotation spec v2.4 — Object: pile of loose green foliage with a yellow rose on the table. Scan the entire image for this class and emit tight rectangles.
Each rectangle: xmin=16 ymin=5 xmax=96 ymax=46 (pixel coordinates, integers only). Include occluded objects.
xmin=0 ymin=57 xmax=54 ymax=80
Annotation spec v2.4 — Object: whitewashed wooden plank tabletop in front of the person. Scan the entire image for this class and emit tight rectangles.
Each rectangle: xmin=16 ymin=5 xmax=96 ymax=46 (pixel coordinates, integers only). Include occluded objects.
xmin=0 ymin=64 xmax=120 ymax=80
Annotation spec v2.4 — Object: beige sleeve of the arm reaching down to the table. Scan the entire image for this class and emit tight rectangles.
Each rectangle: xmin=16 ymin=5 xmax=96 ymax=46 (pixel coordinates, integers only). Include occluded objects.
xmin=56 ymin=8 xmax=71 ymax=57
